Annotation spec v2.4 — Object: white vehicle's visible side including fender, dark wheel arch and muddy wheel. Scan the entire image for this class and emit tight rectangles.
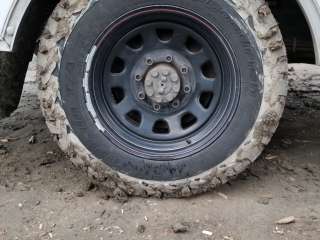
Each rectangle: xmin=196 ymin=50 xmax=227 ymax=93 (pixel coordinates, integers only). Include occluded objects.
xmin=0 ymin=0 xmax=320 ymax=197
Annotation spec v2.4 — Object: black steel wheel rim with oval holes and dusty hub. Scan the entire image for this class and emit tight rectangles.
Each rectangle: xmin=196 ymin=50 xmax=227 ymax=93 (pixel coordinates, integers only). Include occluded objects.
xmin=89 ymin=8 xmax=240 ymax=160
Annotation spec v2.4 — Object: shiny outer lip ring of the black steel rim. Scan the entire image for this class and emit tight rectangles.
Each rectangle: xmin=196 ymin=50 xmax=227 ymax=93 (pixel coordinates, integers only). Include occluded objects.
xmin=87 ymin=5 xmax=241 ymax=161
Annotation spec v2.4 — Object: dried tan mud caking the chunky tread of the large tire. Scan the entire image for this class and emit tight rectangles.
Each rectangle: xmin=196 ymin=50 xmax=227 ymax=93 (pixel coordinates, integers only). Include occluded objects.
xmin=37 ymin=0 xmax=287 ymax=197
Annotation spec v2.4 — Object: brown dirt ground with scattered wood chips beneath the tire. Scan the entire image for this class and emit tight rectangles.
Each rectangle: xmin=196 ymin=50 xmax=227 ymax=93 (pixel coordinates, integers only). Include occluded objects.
xmin=0 ymin=79 xmax=320 ymax=240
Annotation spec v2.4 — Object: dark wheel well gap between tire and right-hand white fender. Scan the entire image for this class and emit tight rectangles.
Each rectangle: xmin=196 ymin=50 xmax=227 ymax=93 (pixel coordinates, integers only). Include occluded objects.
xmin=267 ymin=0 xmax=315 ymax=64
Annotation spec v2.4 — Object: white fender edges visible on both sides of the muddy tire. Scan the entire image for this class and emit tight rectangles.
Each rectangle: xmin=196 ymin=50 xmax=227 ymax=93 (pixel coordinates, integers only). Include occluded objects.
xmin=0 ymin=0 xmax=320 ymax=65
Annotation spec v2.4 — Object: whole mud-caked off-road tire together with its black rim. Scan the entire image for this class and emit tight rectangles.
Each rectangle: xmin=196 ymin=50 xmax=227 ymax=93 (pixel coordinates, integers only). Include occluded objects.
xmin=37 ymin=0 xmax=287 ymax=197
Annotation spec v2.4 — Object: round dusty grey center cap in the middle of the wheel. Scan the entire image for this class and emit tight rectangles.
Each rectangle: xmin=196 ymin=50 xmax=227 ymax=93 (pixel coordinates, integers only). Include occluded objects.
xmin=144 ymin=63 xmax=181 ymax=103
